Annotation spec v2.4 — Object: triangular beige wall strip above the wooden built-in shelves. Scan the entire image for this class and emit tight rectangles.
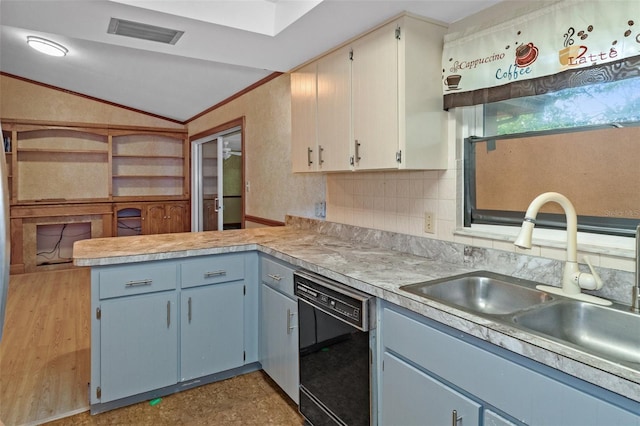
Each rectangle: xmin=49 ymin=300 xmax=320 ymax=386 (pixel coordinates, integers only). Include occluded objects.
xmin=0 ymin=75 xmax=184 ymax=129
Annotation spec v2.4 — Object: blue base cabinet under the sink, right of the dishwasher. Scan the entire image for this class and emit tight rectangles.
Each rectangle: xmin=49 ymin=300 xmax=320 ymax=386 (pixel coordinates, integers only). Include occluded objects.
xmin=379 ymin=303 xmax=640 ymax=426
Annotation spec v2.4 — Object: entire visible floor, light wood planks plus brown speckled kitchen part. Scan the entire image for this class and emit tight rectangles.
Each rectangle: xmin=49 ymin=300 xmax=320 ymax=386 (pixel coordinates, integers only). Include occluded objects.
xmin=0 ymin=269 xmax=303 ymax=426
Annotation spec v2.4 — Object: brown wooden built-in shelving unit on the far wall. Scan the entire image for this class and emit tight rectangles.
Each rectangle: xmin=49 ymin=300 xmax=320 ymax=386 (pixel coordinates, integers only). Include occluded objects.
xmin=2 ymin=119 xmax=190 ymax=273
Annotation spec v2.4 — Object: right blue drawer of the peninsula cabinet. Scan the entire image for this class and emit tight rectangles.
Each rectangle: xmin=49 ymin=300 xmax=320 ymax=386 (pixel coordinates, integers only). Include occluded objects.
xmin=180 ymin=254 xmax=244 ymax=288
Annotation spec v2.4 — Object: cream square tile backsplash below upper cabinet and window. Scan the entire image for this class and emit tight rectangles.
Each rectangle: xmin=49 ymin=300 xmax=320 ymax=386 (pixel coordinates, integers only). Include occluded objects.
xmin=326 ymin=168 xmax=635 ymax=272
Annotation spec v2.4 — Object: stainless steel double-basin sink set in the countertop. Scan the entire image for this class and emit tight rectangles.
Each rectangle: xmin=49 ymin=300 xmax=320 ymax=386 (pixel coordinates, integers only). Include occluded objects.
xmin=400 ymin=271 xmax=640 ymax=370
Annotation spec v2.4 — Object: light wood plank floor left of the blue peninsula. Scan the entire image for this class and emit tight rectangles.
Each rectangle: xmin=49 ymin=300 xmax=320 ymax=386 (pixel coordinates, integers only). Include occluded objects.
xmin=0 ymin=269 xmax=91 ymax=426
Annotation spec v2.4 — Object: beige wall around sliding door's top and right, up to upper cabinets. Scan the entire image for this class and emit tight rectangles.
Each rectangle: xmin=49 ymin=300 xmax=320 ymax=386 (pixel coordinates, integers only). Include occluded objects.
xmin=188 ymin=74 xmax=325 ymax=222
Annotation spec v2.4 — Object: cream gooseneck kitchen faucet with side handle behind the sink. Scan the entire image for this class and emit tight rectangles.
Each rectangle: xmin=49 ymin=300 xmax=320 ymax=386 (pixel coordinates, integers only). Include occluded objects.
xmin=514 ymin=192 xmax=611 ymax=305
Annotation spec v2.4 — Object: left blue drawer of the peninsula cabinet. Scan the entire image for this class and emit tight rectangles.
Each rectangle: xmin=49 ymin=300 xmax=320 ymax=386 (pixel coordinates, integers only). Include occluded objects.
xmin=99 ymin=263 xmax=177 ymax=299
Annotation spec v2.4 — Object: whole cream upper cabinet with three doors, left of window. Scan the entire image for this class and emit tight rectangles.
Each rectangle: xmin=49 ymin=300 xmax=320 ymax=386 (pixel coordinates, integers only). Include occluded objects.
xmin=291 ymin=15 xmax=447 ymax=172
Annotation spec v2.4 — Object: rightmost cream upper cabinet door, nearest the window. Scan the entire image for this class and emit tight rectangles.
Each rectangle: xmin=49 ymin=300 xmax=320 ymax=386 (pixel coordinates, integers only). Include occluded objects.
xmin=351 ymin=23 xmax=398 ymax=169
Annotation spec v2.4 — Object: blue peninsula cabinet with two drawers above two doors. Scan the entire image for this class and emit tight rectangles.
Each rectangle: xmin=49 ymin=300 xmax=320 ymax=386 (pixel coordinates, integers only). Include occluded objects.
xmin=89 ymin=253 xmax=259 ymax=414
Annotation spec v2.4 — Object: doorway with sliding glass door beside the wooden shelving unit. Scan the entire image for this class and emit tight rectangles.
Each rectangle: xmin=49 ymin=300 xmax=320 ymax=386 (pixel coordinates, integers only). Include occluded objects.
xmin=191 ymin=120 xmax=244 ymax=231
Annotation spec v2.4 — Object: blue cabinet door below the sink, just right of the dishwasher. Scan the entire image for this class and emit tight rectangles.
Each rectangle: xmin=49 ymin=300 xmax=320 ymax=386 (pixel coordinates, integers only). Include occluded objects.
xmin=381 ymin=352 xmax=482 ymax=426
